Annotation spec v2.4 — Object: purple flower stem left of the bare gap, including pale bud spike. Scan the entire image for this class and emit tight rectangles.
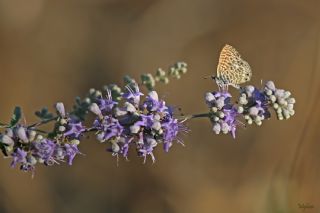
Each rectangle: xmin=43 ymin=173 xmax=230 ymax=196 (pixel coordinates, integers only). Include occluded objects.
xmin=0 ymin=62 xmax=188 ymax=174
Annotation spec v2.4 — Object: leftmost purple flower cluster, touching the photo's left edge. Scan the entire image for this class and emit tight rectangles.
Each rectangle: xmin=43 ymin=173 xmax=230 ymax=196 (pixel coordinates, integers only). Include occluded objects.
xmin=0 ymin=103 xmax=85 ymax=175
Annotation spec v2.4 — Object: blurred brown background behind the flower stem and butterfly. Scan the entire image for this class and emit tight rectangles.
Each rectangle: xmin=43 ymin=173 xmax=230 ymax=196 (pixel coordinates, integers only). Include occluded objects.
xmin=0 ymin=0 xmax=320 ymax=213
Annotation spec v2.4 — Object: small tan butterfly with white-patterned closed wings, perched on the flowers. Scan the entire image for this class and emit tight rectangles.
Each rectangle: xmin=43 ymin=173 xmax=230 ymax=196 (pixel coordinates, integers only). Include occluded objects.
xmin=211 ymin=44 xmax=252 ymax=89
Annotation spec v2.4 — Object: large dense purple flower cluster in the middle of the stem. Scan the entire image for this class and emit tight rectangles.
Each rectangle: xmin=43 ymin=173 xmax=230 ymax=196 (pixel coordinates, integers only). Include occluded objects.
xmin=90 ymin=83 xmax=187 ymax=162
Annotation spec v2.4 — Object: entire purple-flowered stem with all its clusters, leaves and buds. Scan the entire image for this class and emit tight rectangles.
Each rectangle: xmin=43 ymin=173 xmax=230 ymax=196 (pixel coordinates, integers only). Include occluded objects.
xmin=0 ymin=62 xmax=295 ymax=174
